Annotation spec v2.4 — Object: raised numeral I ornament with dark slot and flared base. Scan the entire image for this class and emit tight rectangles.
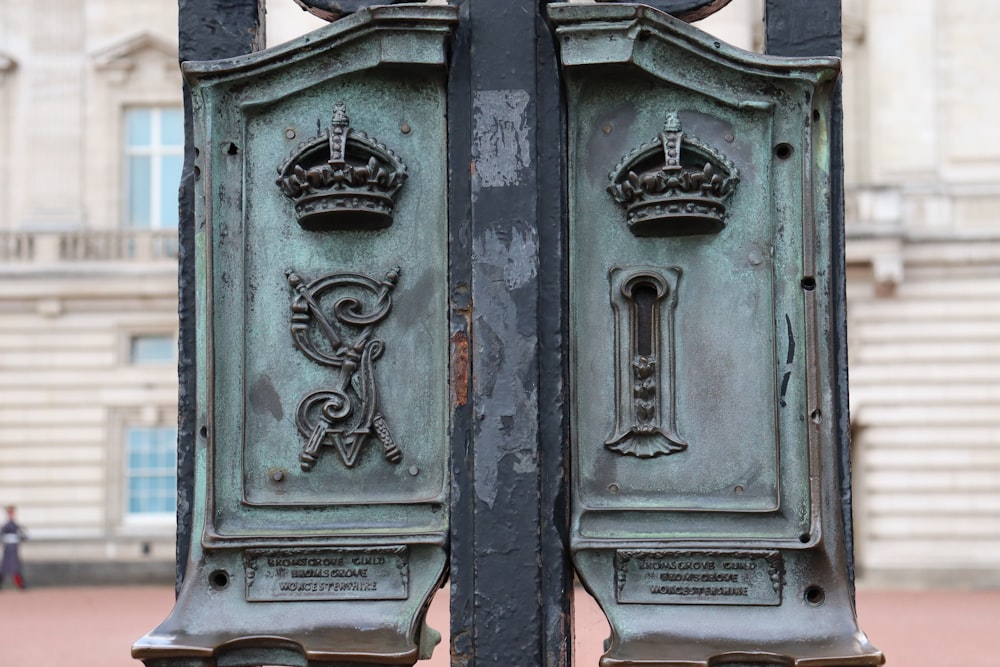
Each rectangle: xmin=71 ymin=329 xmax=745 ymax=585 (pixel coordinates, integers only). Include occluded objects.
xmin=604 ymin=266 xmax=687 ymax=459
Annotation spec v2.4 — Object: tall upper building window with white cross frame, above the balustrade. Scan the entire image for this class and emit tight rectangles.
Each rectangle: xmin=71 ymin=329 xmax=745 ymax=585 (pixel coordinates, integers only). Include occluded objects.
xmin=125 ymin=107 xmax=184 ymax=229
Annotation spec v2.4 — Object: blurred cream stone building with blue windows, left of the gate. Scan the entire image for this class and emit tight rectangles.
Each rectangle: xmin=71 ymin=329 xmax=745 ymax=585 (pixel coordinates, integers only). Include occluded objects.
xmin=0 ymin=0 xmax=184 ymax=578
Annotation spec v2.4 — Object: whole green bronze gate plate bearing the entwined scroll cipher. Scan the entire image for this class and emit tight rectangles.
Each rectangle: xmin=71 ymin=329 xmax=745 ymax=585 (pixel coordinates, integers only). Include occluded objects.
xmin=133 ymin=5 xmax=456 ymax=666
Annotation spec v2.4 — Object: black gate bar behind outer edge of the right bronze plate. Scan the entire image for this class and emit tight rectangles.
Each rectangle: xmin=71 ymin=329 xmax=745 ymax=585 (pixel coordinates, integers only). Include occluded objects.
xmin=764 ymin=0 xmax=854 ymax=585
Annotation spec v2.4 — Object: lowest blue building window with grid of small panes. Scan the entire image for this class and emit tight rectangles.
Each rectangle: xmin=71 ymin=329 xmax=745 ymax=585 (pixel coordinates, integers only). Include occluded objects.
xmin=125 ymin=426 xmax=177 ymax=518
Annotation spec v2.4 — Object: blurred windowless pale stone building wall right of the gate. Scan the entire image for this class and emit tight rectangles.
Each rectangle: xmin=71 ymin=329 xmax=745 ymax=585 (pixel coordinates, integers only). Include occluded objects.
xmin=844 ymin=0 xmax=1000 ymax=585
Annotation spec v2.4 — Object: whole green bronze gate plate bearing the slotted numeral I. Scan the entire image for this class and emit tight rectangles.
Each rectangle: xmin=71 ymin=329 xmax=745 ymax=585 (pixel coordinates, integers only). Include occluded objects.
xmin=549 ymin=4 xmax=882 ymax=667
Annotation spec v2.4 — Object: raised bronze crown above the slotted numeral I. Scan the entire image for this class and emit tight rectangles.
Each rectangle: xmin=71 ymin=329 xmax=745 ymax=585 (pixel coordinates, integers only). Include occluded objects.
xmin=608 ymin=112 xmax=739 ymax=236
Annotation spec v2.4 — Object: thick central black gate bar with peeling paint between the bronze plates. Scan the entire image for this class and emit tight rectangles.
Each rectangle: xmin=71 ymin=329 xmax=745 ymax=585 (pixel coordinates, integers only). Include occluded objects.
xmin=448 ymin=0 xmax=572 ymax=667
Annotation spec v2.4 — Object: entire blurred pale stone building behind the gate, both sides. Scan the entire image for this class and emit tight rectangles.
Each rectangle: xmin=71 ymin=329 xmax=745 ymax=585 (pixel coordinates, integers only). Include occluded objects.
xmin=0 ymin=0 xmax=1000 ymax=585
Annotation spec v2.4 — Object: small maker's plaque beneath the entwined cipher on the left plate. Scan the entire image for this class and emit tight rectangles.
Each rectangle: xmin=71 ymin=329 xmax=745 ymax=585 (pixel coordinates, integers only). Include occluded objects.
xmin=243 ymin=546 xmax=409 ymax=602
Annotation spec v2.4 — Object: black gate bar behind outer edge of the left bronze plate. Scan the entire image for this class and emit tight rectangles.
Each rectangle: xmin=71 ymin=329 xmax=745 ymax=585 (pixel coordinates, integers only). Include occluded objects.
xmin=176 ymin=0 xmax=265 ymax=591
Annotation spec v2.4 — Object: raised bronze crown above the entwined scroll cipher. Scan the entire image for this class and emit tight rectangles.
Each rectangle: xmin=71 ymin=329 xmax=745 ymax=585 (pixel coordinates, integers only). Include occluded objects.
xmin=276 ymin=102 xmax=406 ymax=231
